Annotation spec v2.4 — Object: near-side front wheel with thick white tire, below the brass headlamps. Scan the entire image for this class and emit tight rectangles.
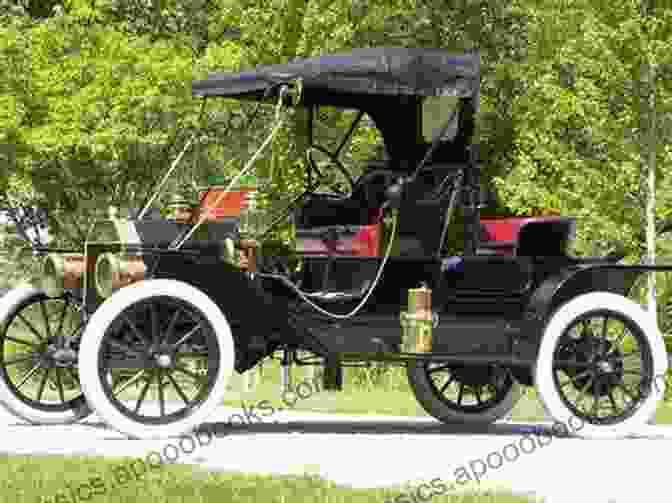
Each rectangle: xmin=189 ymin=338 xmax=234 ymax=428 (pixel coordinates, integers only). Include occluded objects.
xmin=79 ymin=279 xmax=234 ymax=439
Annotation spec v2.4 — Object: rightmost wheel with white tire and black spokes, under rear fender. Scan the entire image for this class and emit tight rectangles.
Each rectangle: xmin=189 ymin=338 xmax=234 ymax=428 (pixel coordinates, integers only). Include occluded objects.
xmin=534 ymin=292 xmax=667 ymax=438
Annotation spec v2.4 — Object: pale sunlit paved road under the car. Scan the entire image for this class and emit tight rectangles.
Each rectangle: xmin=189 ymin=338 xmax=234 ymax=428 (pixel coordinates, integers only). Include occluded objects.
xmin=0 ymin=407 xmax=672 ymax=503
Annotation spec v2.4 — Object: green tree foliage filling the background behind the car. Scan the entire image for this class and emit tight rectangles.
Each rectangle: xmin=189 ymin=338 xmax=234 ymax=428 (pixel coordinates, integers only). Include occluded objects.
xmin=0 ymin=0 xmax=672 ymax=260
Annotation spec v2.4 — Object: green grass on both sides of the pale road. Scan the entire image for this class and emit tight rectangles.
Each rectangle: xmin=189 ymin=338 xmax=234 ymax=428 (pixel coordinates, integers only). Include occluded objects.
xmin=0 ymin=332 xmax=672 ymax=503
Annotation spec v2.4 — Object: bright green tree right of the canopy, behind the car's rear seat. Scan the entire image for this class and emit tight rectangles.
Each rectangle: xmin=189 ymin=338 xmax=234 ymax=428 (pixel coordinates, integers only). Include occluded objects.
xmin=490 ymin=1 xmax=672 ymax=254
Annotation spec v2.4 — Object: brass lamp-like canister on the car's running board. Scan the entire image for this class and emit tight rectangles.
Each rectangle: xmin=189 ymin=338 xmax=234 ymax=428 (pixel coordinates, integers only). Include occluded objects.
xmin=399 ymin=285 xmax=433 ymax=353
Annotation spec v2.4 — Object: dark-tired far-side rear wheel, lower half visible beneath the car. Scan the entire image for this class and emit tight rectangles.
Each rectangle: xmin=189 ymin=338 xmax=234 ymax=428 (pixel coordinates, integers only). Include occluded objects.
xmin=407 ymin=362 xmax=523 ymax=424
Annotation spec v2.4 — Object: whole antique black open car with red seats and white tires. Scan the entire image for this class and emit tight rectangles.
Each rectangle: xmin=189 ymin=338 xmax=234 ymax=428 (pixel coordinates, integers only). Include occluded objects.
xmin=0 ymin=48 xmax=667 ymax=438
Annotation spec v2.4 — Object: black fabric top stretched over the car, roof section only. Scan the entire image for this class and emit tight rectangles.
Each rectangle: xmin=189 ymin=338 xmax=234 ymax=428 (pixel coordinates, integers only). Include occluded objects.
xmin=192 ymin=47 xmax=480 ymax=105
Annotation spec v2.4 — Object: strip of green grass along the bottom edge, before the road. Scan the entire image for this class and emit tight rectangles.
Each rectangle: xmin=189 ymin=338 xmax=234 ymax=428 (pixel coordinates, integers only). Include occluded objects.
xmin=0 ymin=455 xmax=534 ymax=503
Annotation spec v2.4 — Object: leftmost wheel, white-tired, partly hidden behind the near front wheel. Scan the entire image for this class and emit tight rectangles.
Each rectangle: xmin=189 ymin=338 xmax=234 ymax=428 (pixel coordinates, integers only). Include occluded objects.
xmin=0 ymin=285 xmax=91 ymax=424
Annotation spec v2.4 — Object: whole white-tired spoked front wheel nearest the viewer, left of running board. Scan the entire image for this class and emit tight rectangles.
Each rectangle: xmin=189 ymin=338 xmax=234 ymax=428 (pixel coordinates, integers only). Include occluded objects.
xmin=79 ymin=279 xmax=234 ymax=438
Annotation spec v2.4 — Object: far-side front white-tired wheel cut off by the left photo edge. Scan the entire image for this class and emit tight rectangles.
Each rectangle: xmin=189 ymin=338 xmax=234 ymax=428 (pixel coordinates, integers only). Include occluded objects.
xmin=0 ymin=284 xmax=91 ymax=424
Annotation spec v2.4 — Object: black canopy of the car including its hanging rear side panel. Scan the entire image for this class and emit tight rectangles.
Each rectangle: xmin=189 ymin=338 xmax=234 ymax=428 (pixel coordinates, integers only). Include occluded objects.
xmin=192 ymin=47 xmax=480 ymax=171
